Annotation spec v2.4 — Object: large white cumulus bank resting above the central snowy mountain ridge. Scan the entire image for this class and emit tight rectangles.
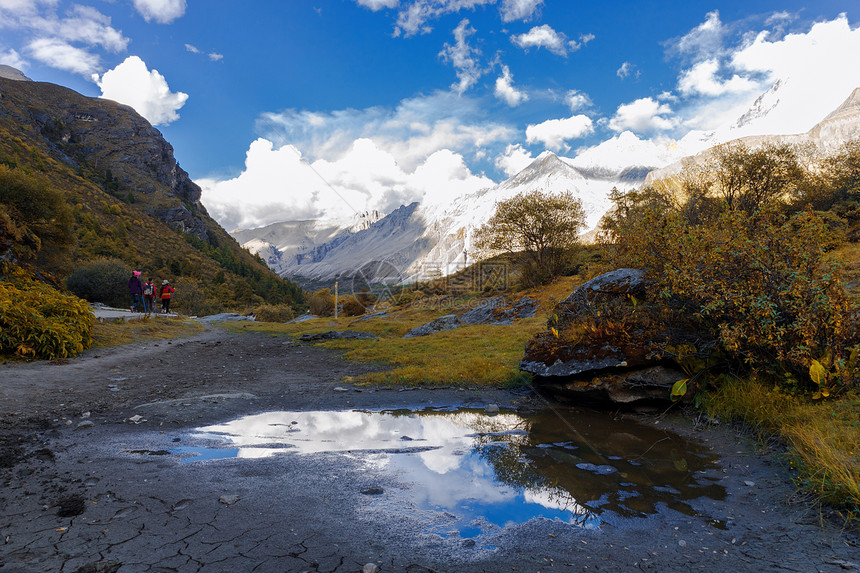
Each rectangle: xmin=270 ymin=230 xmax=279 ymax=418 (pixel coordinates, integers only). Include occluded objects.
xmin=196 ymin=138 xmax=493 ymax=229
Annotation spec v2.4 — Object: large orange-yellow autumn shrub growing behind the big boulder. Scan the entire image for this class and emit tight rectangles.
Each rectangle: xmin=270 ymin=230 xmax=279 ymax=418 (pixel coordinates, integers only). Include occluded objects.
xmin=610 ymin=204 xmax=860 ymax=389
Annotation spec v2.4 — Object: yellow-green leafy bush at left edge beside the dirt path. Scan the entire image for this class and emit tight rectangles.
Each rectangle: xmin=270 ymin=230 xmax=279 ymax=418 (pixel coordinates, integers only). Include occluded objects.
xmin=0 ymin=264 xmax=94 ymax=359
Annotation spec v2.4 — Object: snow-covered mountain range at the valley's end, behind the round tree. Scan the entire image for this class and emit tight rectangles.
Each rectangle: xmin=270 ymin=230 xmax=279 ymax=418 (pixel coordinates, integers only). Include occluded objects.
xmin=239 ymin=152 xmax=654 ymax=281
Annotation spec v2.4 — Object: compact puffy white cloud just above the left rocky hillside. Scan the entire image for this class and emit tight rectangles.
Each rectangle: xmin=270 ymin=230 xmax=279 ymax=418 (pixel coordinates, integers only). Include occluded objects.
xmin=94 ymin=56 xmax=188 ymax=125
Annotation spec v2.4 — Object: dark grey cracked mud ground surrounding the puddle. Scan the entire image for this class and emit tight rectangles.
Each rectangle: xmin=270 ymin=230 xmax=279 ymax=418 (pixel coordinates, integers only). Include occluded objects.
xmin=0 ymin=328 xmax=860 ymax=573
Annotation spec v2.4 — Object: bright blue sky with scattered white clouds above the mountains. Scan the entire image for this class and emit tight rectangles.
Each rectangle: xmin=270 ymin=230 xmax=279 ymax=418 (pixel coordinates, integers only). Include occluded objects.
xmin=0 ymin=0 xmax=860 ymax=228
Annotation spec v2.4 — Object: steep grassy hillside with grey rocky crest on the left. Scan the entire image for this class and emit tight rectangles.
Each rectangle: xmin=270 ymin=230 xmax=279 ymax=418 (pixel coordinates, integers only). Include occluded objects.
xmin=0 ymin=78 xmax=302 ymax=314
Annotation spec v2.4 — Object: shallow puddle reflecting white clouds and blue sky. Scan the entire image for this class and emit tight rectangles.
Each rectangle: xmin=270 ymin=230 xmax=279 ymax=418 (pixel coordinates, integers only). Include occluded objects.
xmin=165 ymin=408 xmax=725 ymax=538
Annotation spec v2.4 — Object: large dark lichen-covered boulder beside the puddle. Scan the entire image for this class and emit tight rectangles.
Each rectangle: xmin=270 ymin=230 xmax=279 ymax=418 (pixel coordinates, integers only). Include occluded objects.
xmin=520 ymin=269 xmax=696 ymax=404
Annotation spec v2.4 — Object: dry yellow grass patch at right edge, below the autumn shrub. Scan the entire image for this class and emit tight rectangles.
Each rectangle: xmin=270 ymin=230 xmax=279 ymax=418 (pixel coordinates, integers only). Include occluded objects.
xmin=705 ymin=380 xmax=860 ymax=521
